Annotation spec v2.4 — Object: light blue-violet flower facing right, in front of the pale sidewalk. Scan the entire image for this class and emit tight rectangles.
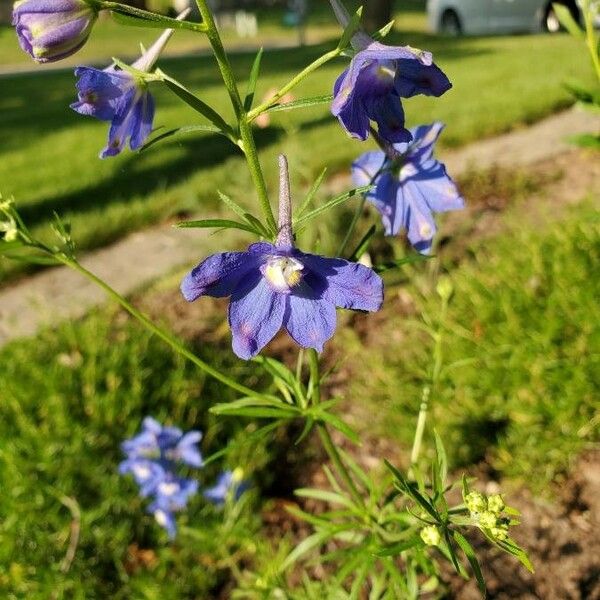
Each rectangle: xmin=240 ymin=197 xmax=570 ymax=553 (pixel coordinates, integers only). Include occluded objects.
xmin=352 ymin=122 xmax=465 ymax=254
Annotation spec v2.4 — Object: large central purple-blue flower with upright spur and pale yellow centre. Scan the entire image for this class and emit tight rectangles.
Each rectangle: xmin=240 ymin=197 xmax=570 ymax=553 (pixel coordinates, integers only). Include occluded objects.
xmin=181 ymin=157 xmax=383 ymax=360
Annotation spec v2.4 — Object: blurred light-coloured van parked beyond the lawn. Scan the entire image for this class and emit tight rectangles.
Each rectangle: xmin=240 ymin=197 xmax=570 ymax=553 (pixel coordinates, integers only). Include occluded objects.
xmin=427 ymin=0 xmax=580 ymax=35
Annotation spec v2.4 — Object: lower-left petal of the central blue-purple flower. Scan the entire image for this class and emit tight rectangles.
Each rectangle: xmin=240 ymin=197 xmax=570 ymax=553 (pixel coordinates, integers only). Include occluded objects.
xmin=229 ymin=271 xmax=286 ymax=360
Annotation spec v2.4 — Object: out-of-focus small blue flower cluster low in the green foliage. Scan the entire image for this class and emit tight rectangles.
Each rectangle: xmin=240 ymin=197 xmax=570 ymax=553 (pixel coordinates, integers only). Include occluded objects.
xmin=119 ymin=417 xmax=247 ymax=539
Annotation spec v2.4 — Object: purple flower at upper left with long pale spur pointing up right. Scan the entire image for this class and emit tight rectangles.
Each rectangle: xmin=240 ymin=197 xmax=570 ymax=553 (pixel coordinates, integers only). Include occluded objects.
xmin=71 ymin=11 xmax=189 ymax=158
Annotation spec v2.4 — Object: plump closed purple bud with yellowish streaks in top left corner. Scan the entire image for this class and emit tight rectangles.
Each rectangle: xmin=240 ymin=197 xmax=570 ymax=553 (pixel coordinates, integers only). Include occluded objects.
xmin=13 ymin=0 xmax=98 ymax=63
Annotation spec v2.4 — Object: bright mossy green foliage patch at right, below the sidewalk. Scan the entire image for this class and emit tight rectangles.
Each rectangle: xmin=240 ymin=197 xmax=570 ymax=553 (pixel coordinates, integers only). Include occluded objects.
xmin=347 ymin=203 xmax=600 ymax=490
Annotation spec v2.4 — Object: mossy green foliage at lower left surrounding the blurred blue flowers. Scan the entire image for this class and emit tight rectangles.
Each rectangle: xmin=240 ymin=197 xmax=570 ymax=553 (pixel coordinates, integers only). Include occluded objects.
xmin=0 ymin=311 xmax=267 ymax=600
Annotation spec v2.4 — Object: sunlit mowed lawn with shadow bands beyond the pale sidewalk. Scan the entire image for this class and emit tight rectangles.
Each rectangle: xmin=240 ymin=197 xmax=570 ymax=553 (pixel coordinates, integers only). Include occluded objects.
xmin=0 ymin=19 xmax=591 ymax=277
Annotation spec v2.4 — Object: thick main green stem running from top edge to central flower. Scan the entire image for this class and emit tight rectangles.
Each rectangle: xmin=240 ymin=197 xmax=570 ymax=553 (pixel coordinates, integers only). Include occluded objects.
xmin=196 ymin=0 xmax=277 ymax=235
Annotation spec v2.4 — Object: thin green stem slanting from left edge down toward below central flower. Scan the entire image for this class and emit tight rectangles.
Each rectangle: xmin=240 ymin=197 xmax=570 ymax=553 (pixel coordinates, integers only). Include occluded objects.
xmin=59 ymin=254 xmax=255 ymax=396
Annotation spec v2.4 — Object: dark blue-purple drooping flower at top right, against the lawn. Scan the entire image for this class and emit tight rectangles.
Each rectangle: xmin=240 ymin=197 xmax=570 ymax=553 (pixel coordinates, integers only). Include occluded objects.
xmin=331 ymin=0 xmax=452 ymax=144
